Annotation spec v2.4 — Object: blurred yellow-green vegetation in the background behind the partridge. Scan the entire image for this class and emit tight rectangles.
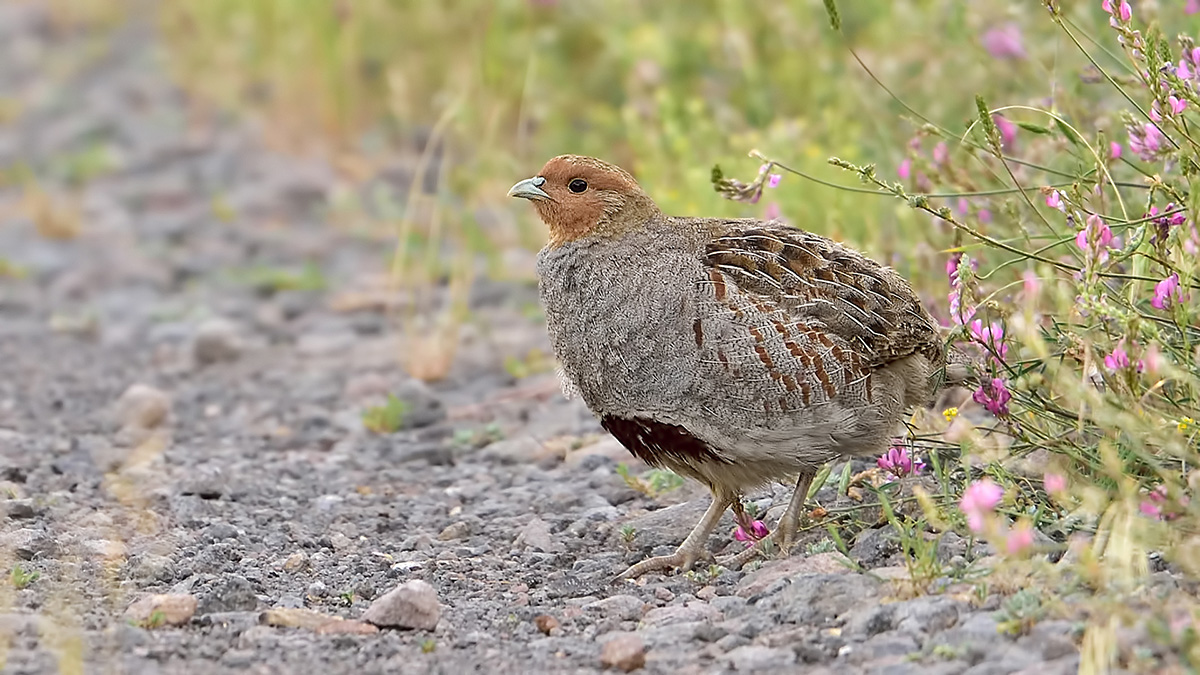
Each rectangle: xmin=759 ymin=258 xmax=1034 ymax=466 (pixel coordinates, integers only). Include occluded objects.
xmin=150 ymin=0 xmax=1123 ymax=285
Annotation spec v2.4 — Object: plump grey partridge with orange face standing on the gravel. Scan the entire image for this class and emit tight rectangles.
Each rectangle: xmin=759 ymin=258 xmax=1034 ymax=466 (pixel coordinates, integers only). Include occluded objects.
xmin=509 ymin=155 xmax=946 ymax=578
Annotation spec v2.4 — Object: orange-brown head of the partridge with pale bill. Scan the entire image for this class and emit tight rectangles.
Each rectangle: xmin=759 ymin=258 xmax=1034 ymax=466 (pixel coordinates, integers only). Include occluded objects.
xmin=509 ymin=155 xmax=659 ymax=246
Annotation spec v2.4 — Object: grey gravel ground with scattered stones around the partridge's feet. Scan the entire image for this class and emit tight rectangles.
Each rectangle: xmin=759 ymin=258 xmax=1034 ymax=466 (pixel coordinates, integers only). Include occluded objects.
xmin=0 ymin=4 xmax=1099 ymax=675
